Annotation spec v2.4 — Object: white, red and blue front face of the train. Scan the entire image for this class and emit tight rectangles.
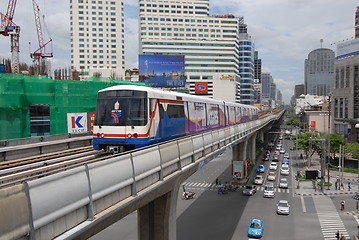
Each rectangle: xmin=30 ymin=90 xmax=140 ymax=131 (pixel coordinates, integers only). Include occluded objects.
xmin=93 ymin=86 xmax=149 ymax=152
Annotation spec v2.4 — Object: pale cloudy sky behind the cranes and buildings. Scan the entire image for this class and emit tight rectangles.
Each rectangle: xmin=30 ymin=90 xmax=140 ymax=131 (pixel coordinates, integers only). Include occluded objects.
xmin=0 ymin=0 xmax=359 ymax=103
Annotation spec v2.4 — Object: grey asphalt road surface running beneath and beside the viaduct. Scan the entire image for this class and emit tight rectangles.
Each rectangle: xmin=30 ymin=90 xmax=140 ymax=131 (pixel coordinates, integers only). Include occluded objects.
xmin=91 ymin=130 xmax=358 ymax=240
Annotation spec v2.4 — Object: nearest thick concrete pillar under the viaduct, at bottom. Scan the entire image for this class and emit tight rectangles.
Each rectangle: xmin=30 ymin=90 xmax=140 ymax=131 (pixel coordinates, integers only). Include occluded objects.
xmin=137 ymin=187 xmax=178 ymax=240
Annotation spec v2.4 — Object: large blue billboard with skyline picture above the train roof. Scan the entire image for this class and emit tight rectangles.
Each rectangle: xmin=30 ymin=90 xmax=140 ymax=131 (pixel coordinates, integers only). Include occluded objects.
xmin=138 ymin=55 xmax=186 ymax=88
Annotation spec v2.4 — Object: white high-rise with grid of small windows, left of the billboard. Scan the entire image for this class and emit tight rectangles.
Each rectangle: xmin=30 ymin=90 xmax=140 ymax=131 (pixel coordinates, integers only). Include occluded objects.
xmin=70 ymin=0 xmax=125 ymax=79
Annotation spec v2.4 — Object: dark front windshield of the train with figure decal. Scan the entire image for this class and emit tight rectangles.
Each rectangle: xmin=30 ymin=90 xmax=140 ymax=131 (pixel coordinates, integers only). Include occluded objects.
xmin=95 ymin=90 xmax=148 ymax=126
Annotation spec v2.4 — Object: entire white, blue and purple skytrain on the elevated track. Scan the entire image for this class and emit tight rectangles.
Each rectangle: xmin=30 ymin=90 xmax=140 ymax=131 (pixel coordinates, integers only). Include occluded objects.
xmin=93 ymin=85 xmax=258 ymax=152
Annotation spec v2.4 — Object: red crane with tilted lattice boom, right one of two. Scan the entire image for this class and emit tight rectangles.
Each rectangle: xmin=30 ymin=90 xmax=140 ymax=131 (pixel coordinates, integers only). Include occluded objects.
xmin=30 ymin=0 xmax=53 ymax=74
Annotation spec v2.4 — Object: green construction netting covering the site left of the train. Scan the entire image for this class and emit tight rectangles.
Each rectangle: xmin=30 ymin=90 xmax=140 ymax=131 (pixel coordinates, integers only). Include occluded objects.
xmin=0 ymin=74 xmax=146 ymax=140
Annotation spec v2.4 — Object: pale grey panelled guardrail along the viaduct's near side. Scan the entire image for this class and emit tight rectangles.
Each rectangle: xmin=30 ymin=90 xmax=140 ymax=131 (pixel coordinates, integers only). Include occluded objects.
xmin=0 ymin=112 xmax=283 ymax=240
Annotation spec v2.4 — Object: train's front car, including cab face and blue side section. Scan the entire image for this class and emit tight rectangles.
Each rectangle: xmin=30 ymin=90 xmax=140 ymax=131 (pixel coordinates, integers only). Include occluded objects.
xmin=93 ymin=85 xmax=186 ymax=152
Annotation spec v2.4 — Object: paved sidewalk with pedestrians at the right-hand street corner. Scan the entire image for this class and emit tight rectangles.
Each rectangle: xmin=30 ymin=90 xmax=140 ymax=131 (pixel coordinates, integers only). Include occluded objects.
xmin=293 ymin=155 xmax=359 ymax=196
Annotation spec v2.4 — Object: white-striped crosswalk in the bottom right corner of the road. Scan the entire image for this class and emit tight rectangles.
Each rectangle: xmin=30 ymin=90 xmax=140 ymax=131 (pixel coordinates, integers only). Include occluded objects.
xmin=313 ymin=196 xmax=350 ymax=240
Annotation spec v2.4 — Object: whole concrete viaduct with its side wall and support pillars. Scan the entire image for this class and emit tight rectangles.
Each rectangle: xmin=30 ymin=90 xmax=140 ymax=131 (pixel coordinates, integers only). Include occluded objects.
xmin=0 ymin=111 xmax=284 ymax=240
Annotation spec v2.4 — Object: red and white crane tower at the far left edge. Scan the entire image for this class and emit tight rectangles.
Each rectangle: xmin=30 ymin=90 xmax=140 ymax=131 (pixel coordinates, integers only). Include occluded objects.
xmin=0 ymin=0 xmax=20 ymax=73
